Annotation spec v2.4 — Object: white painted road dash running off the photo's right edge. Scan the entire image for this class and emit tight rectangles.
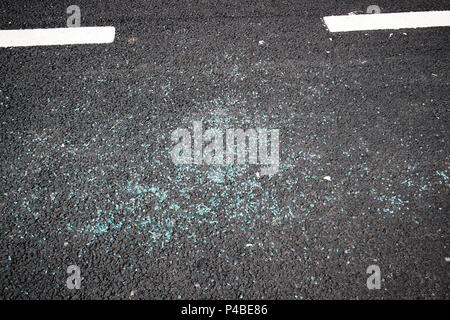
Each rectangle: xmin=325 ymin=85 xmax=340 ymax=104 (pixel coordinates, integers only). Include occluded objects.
xmin=323 ymin=11 xmax=450 ymax=32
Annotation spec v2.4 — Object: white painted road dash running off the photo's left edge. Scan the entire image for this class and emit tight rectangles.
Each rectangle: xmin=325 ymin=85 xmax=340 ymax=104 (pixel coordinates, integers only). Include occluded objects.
xmin=0 ymin=27 xmax=116 ymax=47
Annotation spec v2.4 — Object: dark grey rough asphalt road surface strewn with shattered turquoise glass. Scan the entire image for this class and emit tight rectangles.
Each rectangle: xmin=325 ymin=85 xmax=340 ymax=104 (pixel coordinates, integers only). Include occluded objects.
xmin=0 ymin=0 xmax=450 ymax=299
